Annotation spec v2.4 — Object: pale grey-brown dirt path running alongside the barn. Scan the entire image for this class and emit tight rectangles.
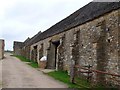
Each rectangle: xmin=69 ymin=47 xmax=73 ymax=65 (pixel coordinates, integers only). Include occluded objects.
xmin=2 ymin=53 xmax=67 ymax=88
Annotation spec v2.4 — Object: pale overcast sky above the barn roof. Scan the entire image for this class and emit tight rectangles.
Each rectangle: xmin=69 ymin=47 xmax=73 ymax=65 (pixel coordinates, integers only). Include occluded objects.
xmin=0 ymin=0 xmax=92 ymax=50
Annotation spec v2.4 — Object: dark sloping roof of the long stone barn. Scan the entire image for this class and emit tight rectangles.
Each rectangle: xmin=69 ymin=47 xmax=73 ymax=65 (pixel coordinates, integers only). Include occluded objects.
xmin=27 ymin=2 xmax=120 ymax=44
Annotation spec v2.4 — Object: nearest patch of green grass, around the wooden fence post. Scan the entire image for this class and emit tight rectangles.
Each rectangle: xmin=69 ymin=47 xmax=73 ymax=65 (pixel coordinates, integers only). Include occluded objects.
xmin=48 ymin=71 xmax=117 ymax=90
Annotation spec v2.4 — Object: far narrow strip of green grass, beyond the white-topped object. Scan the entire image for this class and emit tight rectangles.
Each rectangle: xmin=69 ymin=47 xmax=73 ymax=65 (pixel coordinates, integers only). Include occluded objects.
xmin=12 ymin=55 xmax=38 ymax=68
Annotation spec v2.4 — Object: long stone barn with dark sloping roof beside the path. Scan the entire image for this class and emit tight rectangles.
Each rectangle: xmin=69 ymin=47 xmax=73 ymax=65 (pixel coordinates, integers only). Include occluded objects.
xmin=13 ymin=2 xmax=120 ymax=85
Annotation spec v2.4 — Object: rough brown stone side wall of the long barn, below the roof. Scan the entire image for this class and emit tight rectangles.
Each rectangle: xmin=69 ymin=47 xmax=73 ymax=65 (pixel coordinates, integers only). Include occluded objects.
xmin=31 ymin=10 xmax=120 ymax=85
